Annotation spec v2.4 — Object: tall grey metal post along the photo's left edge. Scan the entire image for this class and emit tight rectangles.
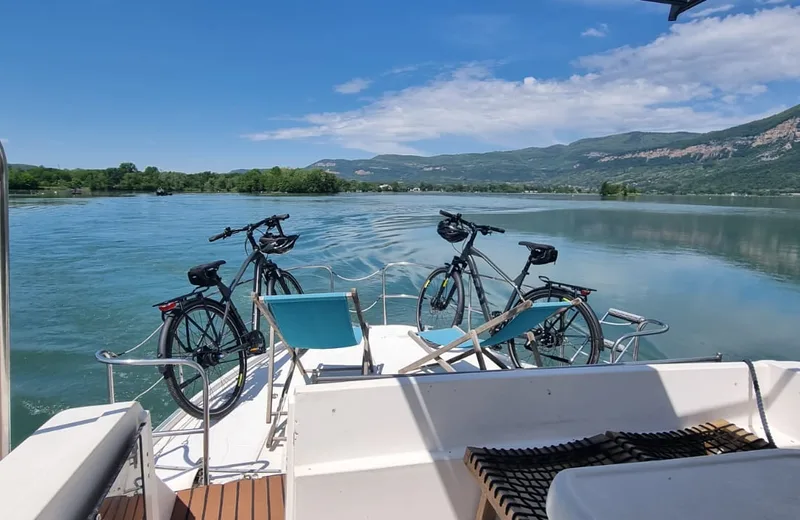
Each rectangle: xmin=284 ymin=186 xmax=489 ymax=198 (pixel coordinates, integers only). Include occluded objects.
xmin=0 ymin=139 xmax=11 ymax=459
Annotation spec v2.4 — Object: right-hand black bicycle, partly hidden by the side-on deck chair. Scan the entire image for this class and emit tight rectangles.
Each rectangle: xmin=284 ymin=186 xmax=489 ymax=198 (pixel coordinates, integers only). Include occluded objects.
xmin=417 ymin=211 xmax=603 ymax=368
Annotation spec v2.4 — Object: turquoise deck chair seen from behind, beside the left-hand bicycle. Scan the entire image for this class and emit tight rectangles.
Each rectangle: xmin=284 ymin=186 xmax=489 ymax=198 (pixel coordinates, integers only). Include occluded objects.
xmin=254 ymin=289 xmax=374 ymax=446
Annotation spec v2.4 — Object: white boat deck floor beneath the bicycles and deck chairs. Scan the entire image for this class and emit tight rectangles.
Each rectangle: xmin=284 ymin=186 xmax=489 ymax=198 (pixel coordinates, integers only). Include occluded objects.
xmin=154 ymin=325 xmax=497 ymax=490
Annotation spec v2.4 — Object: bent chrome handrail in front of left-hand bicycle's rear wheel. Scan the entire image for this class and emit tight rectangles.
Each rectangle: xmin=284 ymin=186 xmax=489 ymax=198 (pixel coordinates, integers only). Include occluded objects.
xmin=94 ymin=350 xmax=211 ymax=486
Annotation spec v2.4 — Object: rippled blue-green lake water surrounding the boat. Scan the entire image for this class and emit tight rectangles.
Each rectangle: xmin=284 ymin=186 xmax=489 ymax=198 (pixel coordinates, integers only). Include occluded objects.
xmin=6 ymin=194 xmax=800 ymax=443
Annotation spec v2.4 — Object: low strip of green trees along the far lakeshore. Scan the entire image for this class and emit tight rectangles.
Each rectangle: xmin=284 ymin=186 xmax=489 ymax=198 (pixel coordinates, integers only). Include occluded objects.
xmin=9 ymin=162 xmax=582 ymax=194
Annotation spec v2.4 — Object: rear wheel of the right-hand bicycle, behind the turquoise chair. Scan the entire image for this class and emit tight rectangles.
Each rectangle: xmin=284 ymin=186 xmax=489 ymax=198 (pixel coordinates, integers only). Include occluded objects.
xmin=508 ymin=286 xmax=603 ymax=368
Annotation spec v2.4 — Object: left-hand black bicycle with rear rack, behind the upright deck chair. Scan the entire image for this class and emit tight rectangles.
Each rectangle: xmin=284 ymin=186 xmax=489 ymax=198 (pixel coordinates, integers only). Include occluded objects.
xmin=155 ymin=215 xmax=303 ymax=419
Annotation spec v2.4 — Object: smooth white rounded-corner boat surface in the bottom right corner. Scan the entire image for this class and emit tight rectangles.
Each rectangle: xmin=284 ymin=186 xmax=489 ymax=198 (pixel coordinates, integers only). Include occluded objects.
xmin=547 ymin=450 xmax=800 ymax=520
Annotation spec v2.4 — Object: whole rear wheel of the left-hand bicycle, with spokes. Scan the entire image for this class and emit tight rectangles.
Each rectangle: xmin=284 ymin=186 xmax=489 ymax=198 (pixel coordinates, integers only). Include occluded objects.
xmin=158 ymin=298 xmax=247 ymax=419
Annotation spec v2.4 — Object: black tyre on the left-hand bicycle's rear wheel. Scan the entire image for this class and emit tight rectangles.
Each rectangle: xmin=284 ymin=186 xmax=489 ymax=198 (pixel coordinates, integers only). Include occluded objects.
xmin=158 ymin=298 xmax=247 ymax=419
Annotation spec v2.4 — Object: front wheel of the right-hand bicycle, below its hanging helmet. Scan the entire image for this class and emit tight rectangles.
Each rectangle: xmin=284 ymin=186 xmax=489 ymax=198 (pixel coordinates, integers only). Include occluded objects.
xmin=417 ymin=267 xmax=464 ymax=331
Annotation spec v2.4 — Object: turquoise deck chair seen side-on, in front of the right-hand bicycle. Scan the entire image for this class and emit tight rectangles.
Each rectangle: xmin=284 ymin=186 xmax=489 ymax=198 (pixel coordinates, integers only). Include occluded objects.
xmin=400 ymin=300 xmax=580 ymax=374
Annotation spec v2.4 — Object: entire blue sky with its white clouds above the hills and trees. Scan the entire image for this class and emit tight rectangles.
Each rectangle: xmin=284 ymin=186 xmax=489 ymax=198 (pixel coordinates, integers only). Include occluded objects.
xmin=0 ymin=0 xmax=800 ymax=172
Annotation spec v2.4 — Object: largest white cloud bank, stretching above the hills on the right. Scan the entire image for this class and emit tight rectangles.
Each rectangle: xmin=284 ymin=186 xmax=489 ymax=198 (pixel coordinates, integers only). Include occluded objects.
xmin=247 ymin=7 xmax=800 ymax=153
